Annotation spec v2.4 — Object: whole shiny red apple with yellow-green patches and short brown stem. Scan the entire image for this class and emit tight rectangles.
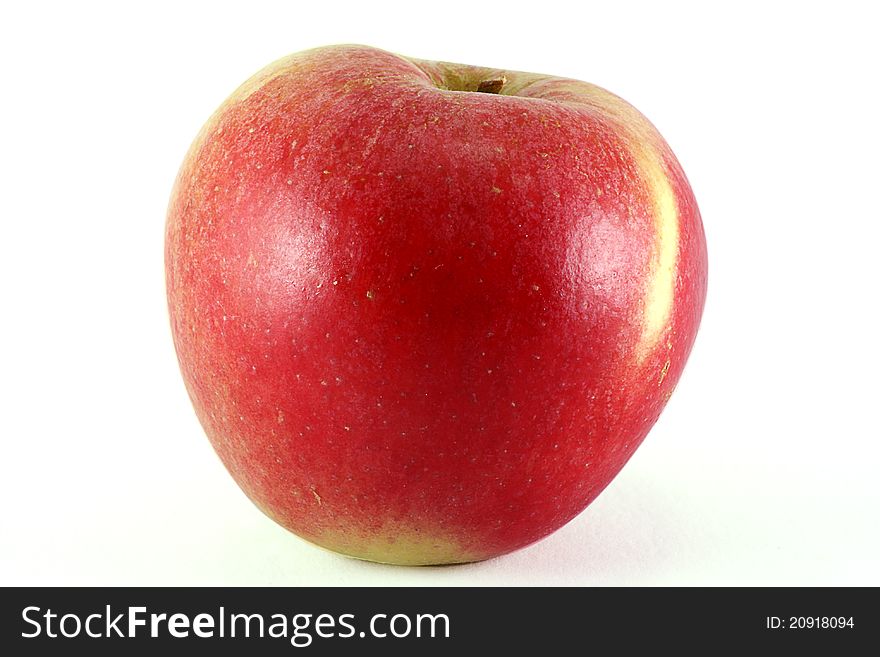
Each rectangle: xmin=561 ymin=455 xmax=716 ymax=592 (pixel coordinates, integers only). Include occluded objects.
xmin=165 ymin=46 xmax=707 ymax=564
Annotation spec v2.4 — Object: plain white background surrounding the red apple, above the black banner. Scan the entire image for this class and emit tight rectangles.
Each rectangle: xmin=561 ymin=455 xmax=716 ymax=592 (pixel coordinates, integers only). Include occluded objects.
xmin=0 ymin=0 xmax=880 ymax=586
